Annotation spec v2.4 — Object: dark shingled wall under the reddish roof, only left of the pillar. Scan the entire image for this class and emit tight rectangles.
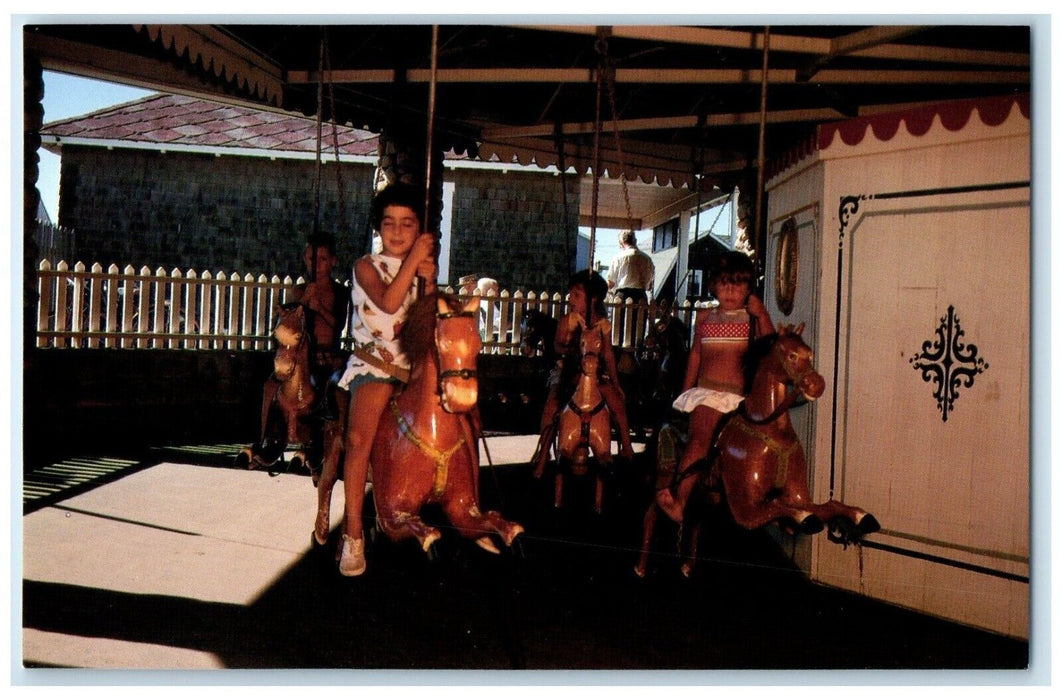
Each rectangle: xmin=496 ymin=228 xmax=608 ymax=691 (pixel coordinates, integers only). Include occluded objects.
xmin=59 ymin=147 xmax=373 ymax=276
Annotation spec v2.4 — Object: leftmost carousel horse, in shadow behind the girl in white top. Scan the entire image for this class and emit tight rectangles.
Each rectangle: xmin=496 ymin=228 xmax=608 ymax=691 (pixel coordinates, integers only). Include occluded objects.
xmin=237 ymin=303 xmax=316 ymax=469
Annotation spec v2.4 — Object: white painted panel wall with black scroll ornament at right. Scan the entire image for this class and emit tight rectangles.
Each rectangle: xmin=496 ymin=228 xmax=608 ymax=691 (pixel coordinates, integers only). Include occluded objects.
xmin=767 ymin=105 xmax=1030 ymax=637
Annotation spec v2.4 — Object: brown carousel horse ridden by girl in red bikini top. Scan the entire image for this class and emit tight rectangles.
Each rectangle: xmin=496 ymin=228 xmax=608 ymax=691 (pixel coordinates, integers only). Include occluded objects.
xmin=634 ymin=324 xmax=880 ymax=576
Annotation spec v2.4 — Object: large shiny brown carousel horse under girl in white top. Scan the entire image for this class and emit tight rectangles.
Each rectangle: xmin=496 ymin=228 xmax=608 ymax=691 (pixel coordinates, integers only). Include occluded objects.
xmin=370 ymin=294 xmax=524 ymax=553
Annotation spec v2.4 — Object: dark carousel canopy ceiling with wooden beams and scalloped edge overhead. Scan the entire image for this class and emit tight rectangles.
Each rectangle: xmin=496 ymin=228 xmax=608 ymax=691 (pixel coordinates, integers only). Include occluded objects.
xmin=23 ymin=18 xmax=1031 ymax=221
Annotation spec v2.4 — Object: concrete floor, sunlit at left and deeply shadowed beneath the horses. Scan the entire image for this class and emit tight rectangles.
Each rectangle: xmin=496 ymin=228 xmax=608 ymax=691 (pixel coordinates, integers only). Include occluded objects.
xmin=16 ymin=436 xmax=1029 ymax=684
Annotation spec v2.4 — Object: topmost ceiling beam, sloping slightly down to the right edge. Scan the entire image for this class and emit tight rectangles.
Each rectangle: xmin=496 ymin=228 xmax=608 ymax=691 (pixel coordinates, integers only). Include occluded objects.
xmin=513 ymin=24 xmax=1029 ymax=67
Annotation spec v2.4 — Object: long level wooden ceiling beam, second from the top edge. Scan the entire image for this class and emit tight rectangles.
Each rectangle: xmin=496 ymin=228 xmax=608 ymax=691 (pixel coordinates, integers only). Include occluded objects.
xmin=286 ymin=68 xmax=1029 ymax=85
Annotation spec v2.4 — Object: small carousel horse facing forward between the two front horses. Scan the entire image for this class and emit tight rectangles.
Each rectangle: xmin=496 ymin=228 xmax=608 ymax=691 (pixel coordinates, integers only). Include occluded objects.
xmin=553 ymin=325 xmax=612 ymax=514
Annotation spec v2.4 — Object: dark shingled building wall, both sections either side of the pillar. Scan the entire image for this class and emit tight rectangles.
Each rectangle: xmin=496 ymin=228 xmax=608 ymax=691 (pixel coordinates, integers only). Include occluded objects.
xmin=53 ymin=146 xmax=579 ymax=291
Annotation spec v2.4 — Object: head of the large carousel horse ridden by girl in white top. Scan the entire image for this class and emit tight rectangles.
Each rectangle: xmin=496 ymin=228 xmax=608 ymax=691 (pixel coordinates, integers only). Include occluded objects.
xmin=434 ymin=294 xmax=482 ymax=413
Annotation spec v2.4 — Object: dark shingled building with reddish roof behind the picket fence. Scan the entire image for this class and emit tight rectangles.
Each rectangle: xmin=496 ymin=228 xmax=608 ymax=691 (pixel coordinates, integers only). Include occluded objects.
xmin=41 ymin=93 xmax=580 ymax=290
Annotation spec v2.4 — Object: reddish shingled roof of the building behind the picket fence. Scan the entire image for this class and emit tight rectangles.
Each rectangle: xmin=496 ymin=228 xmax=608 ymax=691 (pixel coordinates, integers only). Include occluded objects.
xmin=40 ymin=93 xmax=379 ymax=157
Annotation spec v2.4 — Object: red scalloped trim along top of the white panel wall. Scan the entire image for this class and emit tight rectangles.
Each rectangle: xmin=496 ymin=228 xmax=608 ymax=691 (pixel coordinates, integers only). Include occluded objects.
xmin=818 ymin=93 xmax=1029 ymax=151
